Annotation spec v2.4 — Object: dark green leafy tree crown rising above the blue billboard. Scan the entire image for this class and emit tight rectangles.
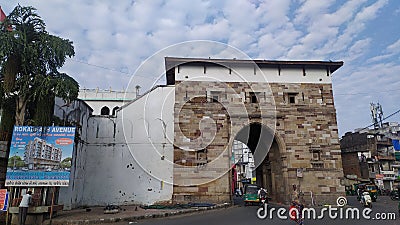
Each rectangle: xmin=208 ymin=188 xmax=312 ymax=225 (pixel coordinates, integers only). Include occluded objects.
xmin=0 ymin=5 xmax=79 ymax=125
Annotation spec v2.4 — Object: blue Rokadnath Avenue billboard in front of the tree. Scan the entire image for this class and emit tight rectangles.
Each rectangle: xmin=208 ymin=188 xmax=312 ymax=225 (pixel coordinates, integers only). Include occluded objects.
xmin=6 ymin=126 xmax=75 ymax=187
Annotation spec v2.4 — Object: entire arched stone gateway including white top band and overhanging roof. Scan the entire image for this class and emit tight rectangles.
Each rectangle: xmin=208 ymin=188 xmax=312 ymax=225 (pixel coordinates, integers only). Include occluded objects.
xmin=166 ymin=57 xmax=344 ymax=203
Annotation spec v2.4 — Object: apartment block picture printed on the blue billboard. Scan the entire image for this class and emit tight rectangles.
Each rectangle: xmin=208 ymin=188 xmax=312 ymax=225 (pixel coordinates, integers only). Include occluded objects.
xmin=24 ymin=137 xmax=62 ymax=171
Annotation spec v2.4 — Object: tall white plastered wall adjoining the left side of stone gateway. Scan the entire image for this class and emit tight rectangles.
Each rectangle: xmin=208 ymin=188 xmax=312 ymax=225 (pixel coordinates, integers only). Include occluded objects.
xmin=61 ymin=86 xmax=175 ymax=208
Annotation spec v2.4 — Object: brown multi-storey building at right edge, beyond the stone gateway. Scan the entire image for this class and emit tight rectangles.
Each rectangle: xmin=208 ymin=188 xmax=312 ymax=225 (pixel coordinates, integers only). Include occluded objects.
xmin=340 ymin=122 xmax=400 ymax=190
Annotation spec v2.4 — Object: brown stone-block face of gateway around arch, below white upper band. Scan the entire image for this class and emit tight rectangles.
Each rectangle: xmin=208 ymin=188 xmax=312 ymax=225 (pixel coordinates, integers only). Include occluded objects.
xmin=173 ymin=81 xmax=344 ymax=204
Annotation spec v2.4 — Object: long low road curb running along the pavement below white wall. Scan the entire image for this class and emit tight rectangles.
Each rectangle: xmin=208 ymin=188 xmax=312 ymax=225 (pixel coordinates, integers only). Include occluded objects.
xmin=44 ymin=203 xmax=232 ymax=225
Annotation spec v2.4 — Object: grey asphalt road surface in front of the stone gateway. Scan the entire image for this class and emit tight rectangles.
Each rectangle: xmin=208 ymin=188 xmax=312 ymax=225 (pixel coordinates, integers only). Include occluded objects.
xmin=96 ymin=196 xmax=400 ymax=225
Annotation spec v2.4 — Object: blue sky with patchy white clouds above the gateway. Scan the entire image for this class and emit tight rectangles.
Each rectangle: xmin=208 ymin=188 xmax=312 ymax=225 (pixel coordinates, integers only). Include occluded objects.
xmin=0 ymin=0 xmax=400 ymax=136
